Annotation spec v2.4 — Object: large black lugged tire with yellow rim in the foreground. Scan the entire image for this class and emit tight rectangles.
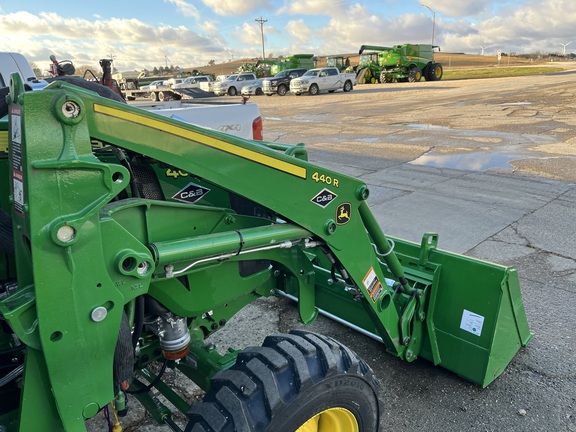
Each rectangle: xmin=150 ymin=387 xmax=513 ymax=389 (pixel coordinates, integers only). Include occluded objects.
xmin=186 ymin=331 xmax=381 ymax=432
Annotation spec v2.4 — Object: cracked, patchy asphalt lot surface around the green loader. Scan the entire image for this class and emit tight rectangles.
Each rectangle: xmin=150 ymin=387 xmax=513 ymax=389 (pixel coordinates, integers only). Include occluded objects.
xmin=89 ymin=69 xmax=576 ymax=432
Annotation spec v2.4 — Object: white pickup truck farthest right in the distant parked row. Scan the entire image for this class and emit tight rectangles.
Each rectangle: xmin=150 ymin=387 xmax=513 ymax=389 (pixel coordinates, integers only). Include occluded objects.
xmin=290 ymin=67 xmax=356 ymax=96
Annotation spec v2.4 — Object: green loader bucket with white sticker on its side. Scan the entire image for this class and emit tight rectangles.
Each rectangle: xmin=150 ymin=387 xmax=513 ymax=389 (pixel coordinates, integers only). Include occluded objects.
xmin=308 ymin=234 xmax=533 ymax=387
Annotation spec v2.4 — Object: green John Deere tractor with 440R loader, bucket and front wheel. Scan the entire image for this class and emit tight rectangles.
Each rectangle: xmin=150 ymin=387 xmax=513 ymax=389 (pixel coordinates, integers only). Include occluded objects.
xmin=0 ymin=69 xmax=532 ymax=432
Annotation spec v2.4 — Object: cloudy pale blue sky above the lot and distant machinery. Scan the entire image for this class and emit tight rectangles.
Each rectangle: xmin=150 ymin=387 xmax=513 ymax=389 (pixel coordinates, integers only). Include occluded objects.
xmin=0 ymin=0 xmax=576 ymax=71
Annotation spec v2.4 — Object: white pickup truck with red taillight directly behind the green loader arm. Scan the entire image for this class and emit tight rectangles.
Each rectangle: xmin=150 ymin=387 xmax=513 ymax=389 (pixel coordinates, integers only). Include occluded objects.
xmin=0 ymin=52 xmax=262 ymax=140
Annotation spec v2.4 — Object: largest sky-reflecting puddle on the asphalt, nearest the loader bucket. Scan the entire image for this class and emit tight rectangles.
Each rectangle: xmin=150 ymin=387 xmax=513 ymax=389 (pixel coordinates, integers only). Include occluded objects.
xmin=410 ymin=151 xmax=526 ymax=171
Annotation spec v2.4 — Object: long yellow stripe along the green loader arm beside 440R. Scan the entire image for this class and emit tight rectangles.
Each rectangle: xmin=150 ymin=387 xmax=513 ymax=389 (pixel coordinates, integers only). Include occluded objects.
xmin=94 ymin=104 xmax=306 ymax=179
